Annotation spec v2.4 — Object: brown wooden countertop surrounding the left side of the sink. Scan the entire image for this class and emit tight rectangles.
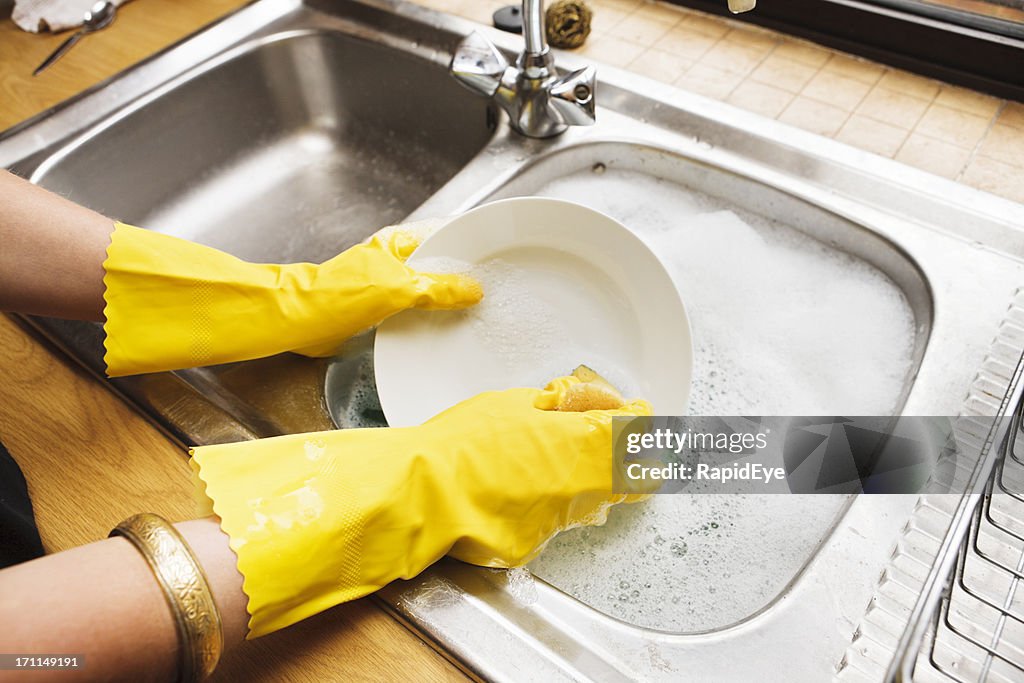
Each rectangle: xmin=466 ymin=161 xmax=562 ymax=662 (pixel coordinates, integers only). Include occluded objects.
xmin=0 ymin=0 xmax=467 ymax=681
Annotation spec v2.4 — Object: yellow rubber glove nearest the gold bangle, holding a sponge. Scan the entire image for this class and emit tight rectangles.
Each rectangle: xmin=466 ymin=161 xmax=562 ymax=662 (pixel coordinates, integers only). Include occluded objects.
xmin=191 ymin=377 xmax=650 ymax=638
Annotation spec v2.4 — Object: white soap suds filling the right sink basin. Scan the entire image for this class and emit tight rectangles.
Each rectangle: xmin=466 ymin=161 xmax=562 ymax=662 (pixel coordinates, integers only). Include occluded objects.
xmin=520 ymin=169 xmax=914 ymax=632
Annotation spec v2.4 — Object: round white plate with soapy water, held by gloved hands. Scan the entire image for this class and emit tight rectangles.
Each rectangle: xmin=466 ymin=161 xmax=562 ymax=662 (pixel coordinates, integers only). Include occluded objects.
xmin=374 ymin=198 xmax=693 ymax=427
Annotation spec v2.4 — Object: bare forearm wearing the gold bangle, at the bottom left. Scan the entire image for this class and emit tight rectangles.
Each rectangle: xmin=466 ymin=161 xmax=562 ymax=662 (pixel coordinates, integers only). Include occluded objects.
xmin=0 ymin=517 xmax=249 ymax=681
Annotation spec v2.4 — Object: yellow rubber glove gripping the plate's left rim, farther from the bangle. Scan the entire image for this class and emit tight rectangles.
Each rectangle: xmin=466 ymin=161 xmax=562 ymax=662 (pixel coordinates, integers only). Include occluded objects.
xmin=103 ymin=223 xmax=483 ymax=377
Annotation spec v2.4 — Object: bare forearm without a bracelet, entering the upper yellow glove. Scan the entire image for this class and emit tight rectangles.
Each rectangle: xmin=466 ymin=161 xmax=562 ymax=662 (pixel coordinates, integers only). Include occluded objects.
xmin=0 ymin=170 xmax=114 ymax=321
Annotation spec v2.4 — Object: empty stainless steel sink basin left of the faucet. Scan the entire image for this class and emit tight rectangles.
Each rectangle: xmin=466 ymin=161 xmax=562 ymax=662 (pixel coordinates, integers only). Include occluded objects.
xmin=32 ymin=32 xmax=494 ymax=262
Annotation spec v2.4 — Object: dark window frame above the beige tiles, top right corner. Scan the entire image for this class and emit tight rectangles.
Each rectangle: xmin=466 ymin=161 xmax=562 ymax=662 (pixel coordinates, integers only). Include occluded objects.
xmin=669 ymin=0 xmax=1024 ymax=101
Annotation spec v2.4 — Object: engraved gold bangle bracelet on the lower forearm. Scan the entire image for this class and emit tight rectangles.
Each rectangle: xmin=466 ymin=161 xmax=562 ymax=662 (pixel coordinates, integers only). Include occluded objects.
xmin=111 ymin=512 xmax=224 ymax=683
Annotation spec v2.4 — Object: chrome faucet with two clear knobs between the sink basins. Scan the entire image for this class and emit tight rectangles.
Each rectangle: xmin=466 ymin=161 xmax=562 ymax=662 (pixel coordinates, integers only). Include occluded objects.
xmin=450 ymin=0 xmax=597 ymax=137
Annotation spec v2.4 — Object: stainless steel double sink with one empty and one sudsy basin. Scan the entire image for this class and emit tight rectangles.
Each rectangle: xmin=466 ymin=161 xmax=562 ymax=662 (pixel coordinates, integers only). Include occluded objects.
xmin=0 ymin=0 xmax=1024 ymax=681
